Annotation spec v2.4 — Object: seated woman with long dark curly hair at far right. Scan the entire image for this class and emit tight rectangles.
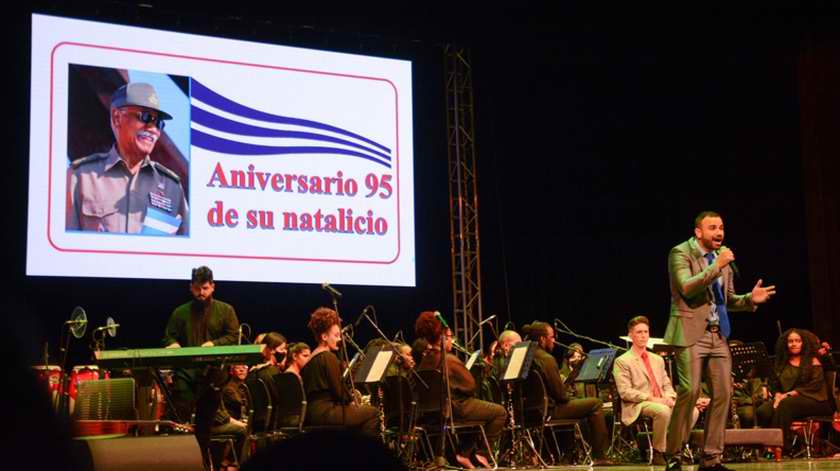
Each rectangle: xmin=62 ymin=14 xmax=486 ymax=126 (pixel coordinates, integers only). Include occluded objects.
xmin=756 ymin=329 xmax=833 ymax=454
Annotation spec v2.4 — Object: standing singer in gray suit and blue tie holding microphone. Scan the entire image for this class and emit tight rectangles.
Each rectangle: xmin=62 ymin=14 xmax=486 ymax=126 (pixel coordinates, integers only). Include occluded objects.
xmin=665 ymin=211 xmax=776 ymax=471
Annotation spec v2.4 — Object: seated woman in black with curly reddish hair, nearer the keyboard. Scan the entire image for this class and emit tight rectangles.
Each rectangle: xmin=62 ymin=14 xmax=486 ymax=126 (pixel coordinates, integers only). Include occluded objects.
xmin=300 ymin=307 xmax=379 ymax=436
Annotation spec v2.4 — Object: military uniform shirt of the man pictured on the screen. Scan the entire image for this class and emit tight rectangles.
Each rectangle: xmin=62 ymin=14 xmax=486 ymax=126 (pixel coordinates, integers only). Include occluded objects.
xmin=66 ymin=147 xmax=189 ymax=235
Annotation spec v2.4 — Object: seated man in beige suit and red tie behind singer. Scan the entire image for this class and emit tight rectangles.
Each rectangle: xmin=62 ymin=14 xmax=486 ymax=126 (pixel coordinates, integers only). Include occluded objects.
xmin=613 ymin=316 xmax=700 ymax=465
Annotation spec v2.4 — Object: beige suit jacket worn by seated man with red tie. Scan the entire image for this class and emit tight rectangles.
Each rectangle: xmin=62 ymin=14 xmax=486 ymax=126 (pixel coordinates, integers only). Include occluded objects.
xmin=613 ymin=349 xmax=677 ymax=425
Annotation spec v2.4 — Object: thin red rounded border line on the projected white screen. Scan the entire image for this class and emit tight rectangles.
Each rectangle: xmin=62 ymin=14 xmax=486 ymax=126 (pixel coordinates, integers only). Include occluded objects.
xmin=47 ymin=41 xmax=402 ymax=265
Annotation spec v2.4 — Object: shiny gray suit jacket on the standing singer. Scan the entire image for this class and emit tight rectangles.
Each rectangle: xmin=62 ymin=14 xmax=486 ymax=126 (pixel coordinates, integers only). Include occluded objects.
xmin=665 ymin=237 xmax=756 ymax=347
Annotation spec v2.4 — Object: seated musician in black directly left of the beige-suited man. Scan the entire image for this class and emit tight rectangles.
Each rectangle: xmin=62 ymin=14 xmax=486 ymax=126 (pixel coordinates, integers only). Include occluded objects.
xmin=522 ymin=321 xmax=610 ymax=465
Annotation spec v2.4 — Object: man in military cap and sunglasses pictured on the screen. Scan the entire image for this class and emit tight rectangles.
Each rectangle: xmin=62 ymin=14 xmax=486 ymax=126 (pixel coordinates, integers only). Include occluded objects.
xmin=66 ymin=82 xmax=189 ymax=235
